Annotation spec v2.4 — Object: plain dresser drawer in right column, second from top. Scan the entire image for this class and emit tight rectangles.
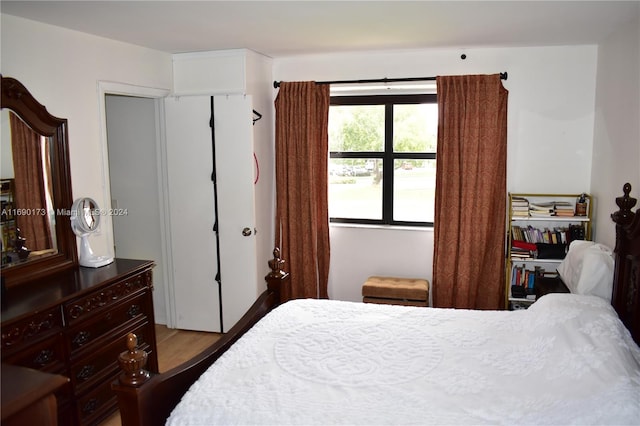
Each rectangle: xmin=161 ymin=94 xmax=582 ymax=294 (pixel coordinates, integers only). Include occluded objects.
xmin=65 ymin=292 xmax=153 ymax=356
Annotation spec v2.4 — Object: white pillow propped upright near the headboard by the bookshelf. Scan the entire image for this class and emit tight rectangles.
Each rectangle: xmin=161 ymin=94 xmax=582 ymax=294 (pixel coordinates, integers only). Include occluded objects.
xmin=558 ymin=240 xmax=614 ymax=302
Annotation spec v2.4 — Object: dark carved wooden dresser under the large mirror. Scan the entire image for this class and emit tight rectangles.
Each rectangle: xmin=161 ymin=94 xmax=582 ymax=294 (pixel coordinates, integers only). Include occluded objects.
xmin=2 ymin=259 xmax=158 ymax=425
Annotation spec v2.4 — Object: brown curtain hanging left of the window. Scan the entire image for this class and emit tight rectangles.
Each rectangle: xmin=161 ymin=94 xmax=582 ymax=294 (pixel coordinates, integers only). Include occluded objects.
xmin=275 ymin=82 xmax=329 ymax=299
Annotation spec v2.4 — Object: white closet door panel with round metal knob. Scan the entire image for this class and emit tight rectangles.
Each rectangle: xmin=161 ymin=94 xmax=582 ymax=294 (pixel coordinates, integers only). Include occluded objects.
xmin=213 ymin=95 xmax=259 ymax=331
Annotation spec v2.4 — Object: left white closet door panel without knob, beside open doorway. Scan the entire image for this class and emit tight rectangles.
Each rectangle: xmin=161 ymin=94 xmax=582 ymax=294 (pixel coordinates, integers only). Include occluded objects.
xmin=165 ymin=96 xmax=221 ymax=332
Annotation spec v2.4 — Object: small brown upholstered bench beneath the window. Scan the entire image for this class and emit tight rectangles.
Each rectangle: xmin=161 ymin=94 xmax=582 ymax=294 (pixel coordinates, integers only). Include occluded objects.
xmin=362 ymin=276 xmax=429 ymax=306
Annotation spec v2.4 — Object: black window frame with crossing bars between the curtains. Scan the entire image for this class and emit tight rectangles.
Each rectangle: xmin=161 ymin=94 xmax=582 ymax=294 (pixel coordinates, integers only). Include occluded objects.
xmin=327 ymin=93 xmax=438 ymax=227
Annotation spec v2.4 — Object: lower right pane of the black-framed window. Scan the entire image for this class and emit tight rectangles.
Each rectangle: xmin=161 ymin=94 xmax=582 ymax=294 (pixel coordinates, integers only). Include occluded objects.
xmin=393 ymin=160 xmax=436 ymax=223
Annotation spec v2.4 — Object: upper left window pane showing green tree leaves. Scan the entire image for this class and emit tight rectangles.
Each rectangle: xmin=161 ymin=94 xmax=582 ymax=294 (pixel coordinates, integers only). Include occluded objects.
xmin=329 ymin=105 xmax=384 ymax=152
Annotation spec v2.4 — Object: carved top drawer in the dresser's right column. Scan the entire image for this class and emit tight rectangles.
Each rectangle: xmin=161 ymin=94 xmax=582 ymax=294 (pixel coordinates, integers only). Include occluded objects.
xmin=62 ymin=271 xmax=152 ymax=325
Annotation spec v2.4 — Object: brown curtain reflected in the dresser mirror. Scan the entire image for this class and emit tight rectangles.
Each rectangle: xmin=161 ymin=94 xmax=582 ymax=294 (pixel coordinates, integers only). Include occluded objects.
xmin=9 ymin=113 xmax=53 ymax=251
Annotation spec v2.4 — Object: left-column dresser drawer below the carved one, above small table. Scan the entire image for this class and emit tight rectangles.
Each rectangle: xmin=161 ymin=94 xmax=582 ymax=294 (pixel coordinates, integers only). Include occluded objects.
xmin=2 ymin=335 xmax=66 ymax=373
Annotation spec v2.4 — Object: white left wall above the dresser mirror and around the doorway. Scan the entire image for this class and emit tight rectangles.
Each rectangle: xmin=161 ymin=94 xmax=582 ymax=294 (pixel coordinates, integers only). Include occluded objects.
xmin=0 ymin=15 xmax=173 ymax=323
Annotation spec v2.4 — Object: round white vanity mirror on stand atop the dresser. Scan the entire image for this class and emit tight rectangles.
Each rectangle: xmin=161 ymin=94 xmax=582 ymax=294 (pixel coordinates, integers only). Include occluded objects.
xmin=71 ymin=197 xmax=113 ymax=268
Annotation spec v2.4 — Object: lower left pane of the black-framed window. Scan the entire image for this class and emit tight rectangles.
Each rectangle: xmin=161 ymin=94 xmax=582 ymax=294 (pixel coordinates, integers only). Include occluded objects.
xmin=329 ymin=158 xmax=382 ymax=220
